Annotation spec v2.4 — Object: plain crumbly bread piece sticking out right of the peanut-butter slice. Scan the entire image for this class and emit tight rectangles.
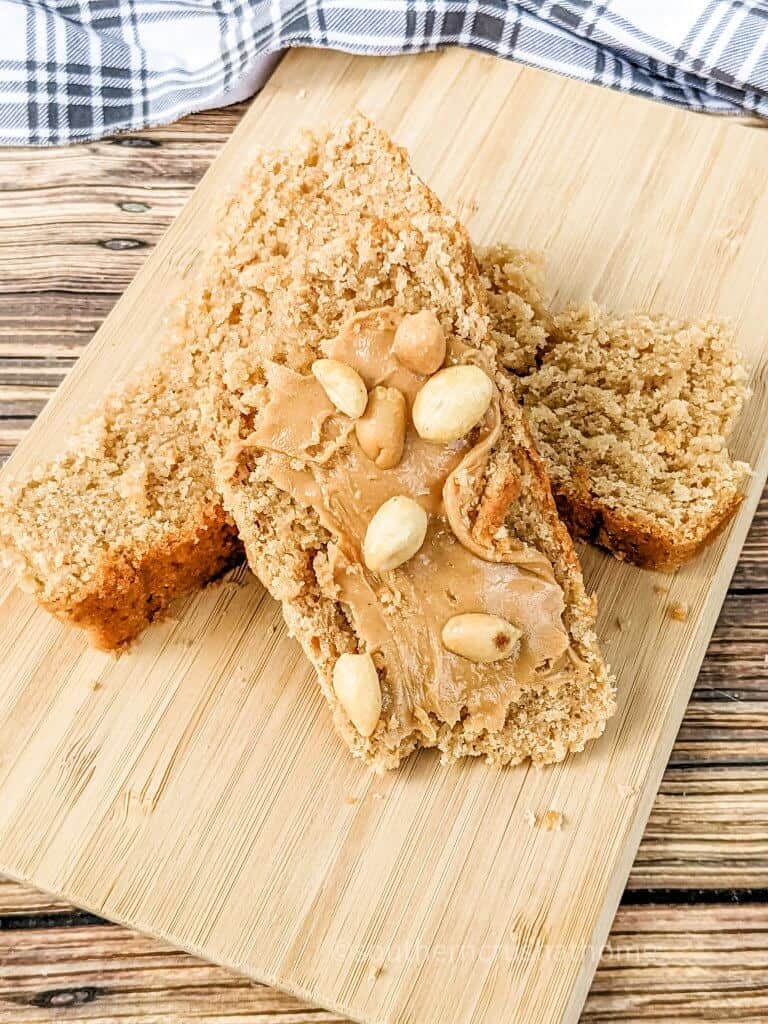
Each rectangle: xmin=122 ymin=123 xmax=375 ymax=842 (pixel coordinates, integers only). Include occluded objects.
xmin=478 ymin=246 xmax=749 ymax=570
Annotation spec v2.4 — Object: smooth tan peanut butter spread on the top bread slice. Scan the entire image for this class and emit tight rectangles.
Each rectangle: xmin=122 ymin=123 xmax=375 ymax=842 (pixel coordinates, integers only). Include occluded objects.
xmin=237 ymin=309 xmax=587 ymax=736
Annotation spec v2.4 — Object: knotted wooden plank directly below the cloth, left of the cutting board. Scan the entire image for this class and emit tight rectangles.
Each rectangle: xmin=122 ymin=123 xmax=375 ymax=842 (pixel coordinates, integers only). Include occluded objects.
xmin=0 ymin=117 xmax=245 ymax=296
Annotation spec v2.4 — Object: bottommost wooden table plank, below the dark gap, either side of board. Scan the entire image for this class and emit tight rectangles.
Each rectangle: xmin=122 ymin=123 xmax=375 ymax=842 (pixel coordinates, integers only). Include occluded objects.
xmin=0 ymin=903 xmax=768 ymax=1024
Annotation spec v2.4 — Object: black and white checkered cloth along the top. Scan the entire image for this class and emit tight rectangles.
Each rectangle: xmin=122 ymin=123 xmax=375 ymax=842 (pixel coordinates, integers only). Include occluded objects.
xmin=0 ymin=0 xmax=768 ymax=144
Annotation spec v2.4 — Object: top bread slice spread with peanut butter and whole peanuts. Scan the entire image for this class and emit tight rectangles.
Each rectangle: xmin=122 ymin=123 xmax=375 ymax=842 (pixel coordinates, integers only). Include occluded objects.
xmin=189 ymin=118 xmax=613 ymax=769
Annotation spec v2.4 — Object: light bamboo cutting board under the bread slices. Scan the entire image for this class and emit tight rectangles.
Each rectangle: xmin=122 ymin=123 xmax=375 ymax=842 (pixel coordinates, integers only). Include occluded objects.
xmin=0 ymin=51 xmax=768 ymax=1024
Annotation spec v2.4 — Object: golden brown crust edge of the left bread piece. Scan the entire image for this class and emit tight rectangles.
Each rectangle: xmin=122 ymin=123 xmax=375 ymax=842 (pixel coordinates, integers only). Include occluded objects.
xmin=40 ymin=508 xmax=243 ymax=650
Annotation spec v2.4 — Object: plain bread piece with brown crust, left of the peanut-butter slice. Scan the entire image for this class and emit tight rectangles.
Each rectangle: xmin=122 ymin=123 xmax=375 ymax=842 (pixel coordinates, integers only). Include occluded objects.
xmin=0 ymin=349 xmax=242 ymax=649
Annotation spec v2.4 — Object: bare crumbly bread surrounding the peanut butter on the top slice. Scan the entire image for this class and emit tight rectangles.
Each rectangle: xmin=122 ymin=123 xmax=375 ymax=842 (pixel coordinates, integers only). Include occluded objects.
xmin=186 ymin=118 xmax=613 ymax=769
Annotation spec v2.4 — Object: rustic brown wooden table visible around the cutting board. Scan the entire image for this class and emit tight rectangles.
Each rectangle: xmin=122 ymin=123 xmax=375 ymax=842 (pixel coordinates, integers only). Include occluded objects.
xmin=0 ymin=106 xmax=768 ymax=1024
